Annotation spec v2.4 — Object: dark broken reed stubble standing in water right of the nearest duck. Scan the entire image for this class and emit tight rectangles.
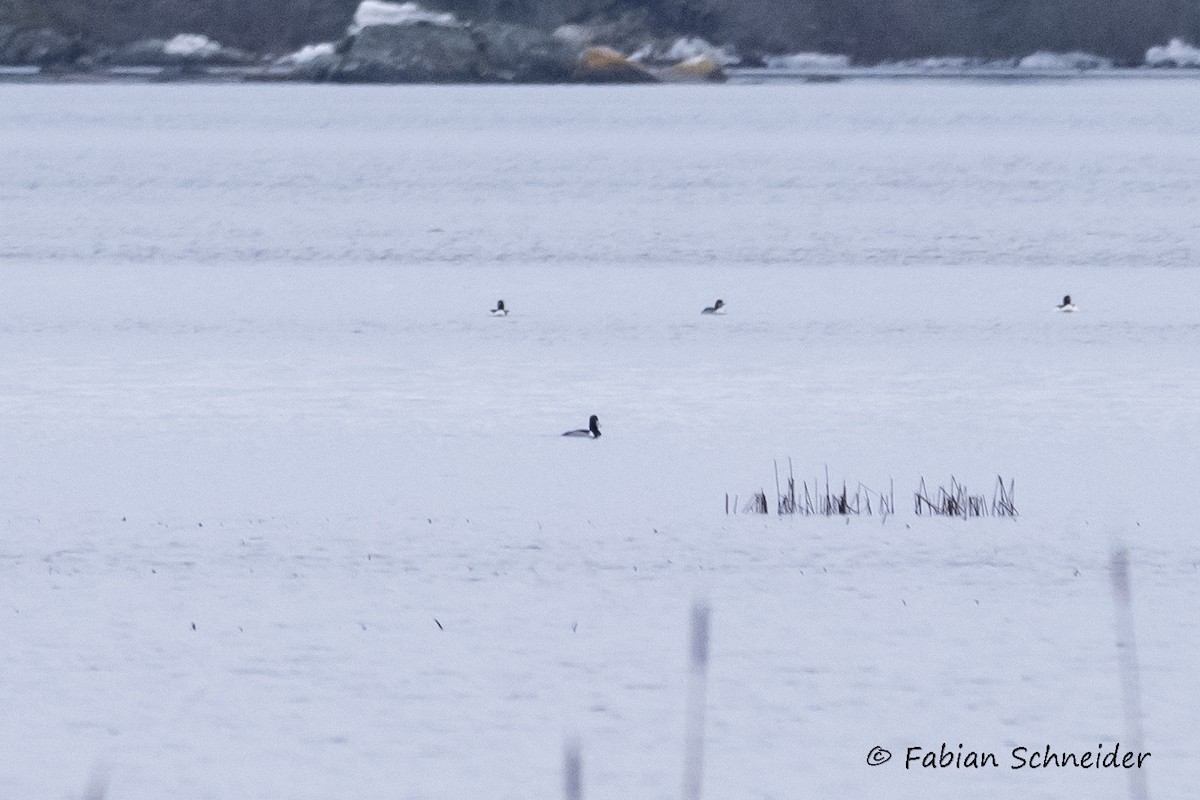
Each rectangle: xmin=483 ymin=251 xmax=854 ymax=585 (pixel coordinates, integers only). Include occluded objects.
xmin=725 ymin=458 xmax=1016 ymax=519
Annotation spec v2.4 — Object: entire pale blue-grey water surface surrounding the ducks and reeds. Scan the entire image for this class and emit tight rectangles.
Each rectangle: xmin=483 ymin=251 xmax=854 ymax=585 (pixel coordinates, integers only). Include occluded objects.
xmin=0 ymin=79 xmax=1200 ymax=800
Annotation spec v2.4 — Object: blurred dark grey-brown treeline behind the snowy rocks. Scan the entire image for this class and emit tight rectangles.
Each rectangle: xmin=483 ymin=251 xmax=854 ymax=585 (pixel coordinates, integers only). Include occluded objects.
xmin=0 ymin=0 xmax=1200 ymax=64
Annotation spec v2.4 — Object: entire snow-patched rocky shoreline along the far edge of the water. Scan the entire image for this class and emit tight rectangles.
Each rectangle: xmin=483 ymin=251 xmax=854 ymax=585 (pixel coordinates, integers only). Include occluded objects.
xmin=7 ymin=0 xmax=1200 ymax=84
